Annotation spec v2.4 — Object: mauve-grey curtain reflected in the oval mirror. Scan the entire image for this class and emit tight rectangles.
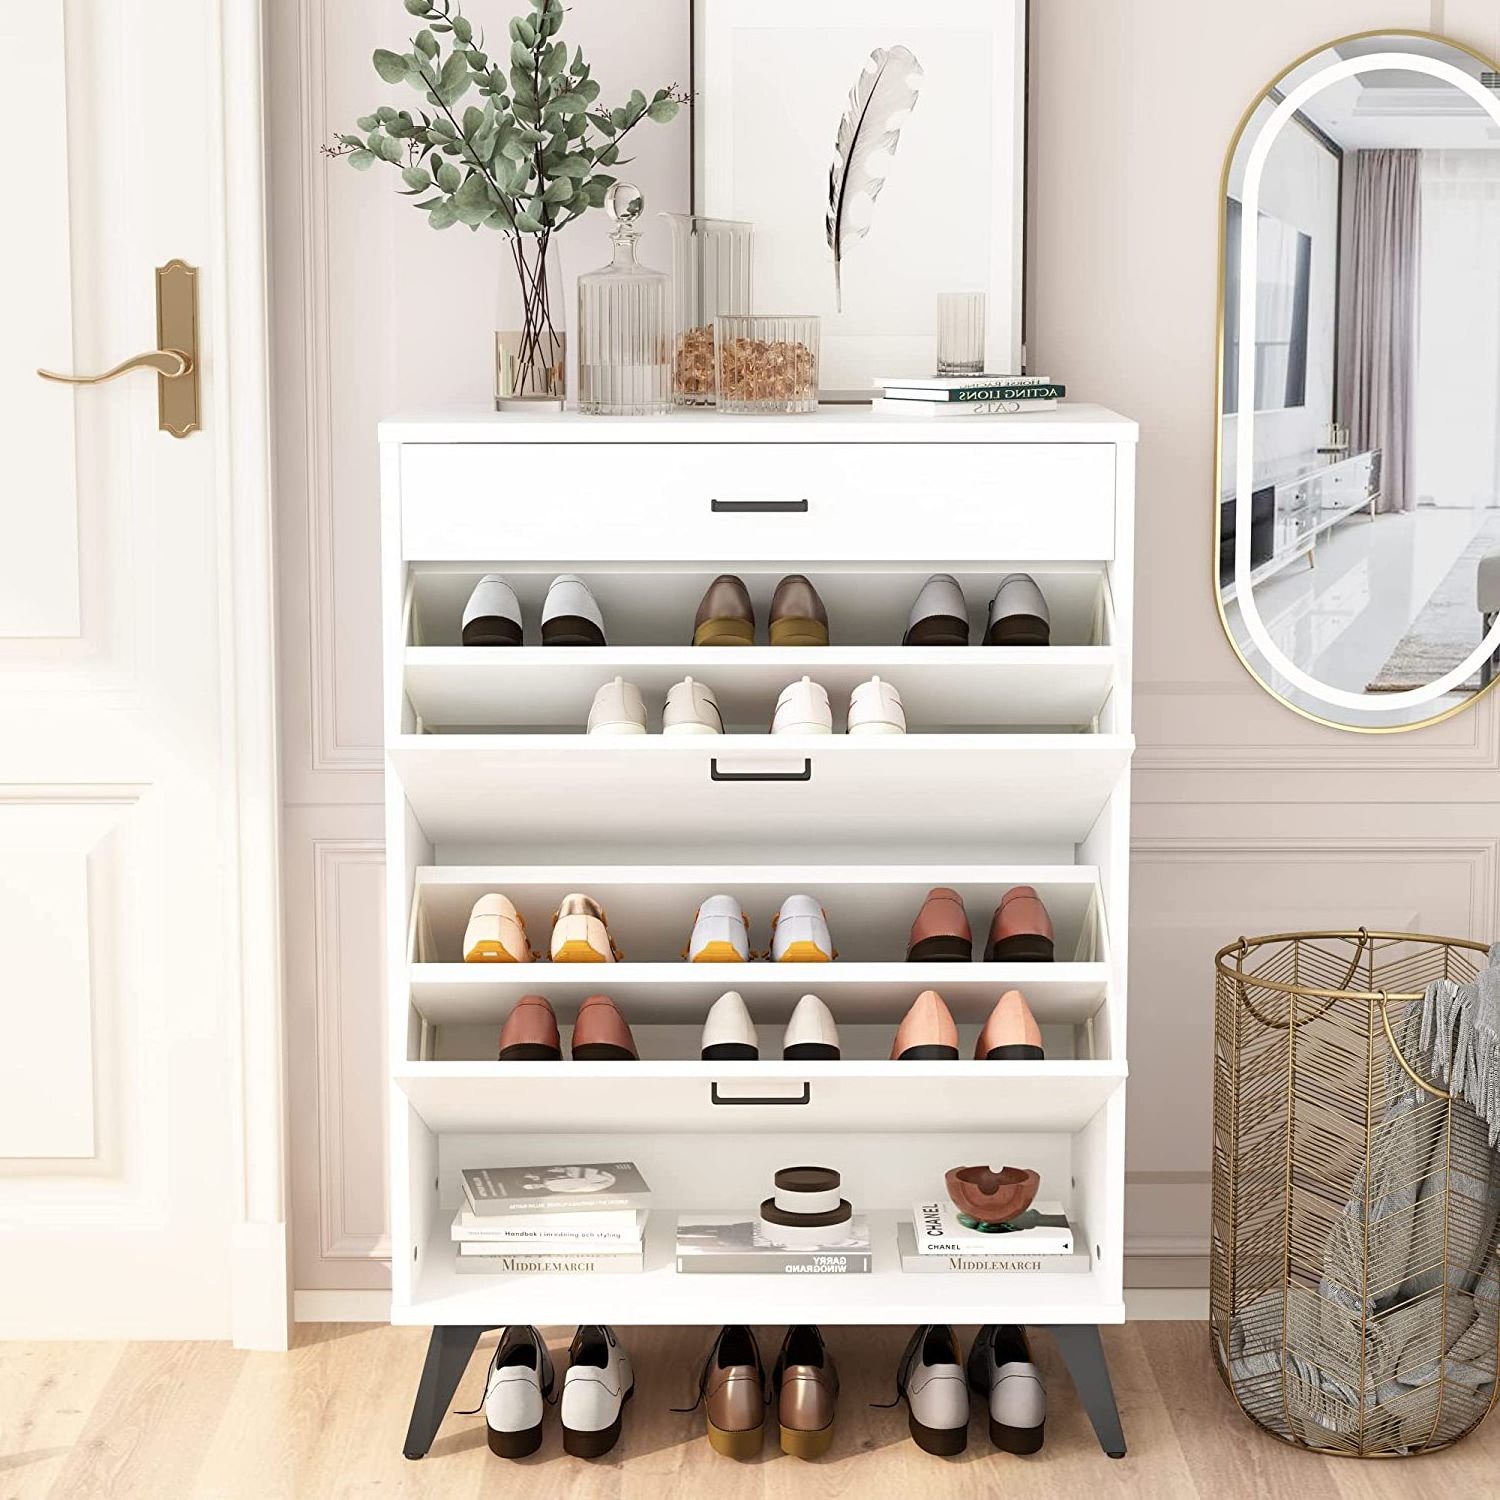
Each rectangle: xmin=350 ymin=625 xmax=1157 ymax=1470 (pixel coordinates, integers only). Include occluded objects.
xmin=1338 ymin=150 xmax=1422 ymax=512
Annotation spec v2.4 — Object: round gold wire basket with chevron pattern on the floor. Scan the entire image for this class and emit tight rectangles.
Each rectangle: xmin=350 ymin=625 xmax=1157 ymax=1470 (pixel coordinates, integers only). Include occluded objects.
xmin=1209 ymin=929 xmax=1500 ymax=1458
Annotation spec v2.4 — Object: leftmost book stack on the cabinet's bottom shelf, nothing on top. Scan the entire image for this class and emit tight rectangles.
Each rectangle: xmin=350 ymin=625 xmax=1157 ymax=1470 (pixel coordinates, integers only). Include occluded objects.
xmin=452 ymin=1161 xmax=651 ymax=1275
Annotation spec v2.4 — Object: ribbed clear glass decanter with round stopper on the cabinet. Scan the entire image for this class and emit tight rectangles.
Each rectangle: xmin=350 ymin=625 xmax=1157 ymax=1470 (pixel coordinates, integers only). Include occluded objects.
xmin=578 ymin=183 xmax=672 ymax=417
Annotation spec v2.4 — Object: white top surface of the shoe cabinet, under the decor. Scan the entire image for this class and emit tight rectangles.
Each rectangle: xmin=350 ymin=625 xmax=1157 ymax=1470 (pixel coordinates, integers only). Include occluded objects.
xmin=380 ymin=402 xmax=1139 ymax=444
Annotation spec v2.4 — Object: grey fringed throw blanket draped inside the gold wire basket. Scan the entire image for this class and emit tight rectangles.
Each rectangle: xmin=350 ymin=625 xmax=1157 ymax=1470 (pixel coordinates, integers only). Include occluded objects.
xmin=1220 ymin=944 xmax=1500 ymax=1452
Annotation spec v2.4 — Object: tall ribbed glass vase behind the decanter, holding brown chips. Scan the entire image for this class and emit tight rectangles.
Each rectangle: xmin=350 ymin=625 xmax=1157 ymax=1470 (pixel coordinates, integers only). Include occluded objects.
xmin=662 ymin=213 xmax=755 ymax=407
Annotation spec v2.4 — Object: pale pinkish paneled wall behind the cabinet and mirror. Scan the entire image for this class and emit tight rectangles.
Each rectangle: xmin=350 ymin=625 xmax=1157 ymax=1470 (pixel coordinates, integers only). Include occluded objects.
xmin=270 ymin=0 xmax=1500 ymax=1289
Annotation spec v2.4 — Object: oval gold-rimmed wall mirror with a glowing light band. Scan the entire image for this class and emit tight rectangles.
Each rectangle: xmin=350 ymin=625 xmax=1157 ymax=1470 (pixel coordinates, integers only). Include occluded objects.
xmin=1214 ymin=32 xmax=1500 ymax=732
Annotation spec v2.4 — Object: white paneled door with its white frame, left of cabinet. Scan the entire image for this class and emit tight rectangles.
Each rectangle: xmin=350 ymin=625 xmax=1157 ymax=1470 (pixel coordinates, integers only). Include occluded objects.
xmin=0 ymin=0 xmax=285 ymax=1344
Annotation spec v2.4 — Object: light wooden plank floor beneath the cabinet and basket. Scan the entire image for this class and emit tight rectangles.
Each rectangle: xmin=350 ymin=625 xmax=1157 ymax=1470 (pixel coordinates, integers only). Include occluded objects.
xmin=0 ymin=1323 xmax=1500 ymax=1500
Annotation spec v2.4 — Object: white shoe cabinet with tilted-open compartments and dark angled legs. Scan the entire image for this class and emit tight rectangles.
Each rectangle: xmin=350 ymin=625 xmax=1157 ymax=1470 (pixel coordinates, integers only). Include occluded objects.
xmin=381 ymin=405 xmax=1136 ymax=1458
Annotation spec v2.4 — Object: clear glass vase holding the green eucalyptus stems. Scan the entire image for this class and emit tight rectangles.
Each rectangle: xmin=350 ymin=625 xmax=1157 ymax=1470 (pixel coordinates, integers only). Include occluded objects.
xmin=495 ymin=233 xmax=567 ymax=411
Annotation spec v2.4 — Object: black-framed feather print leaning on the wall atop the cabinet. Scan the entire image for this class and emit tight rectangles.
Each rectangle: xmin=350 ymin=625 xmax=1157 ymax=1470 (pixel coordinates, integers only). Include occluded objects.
xmin=692 ymin=0 xmax=1026 ymax=401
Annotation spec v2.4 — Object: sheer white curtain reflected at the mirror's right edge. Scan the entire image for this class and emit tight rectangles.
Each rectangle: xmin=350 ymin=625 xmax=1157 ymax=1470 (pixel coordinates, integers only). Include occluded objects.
xmin=1415 ymin=150 xmax=1500 ymax=510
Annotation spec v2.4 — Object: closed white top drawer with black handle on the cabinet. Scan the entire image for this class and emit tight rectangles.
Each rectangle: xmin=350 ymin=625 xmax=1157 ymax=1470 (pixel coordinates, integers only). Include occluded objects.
xmin=401 ymin=443 xmax=1115 ymax=566
